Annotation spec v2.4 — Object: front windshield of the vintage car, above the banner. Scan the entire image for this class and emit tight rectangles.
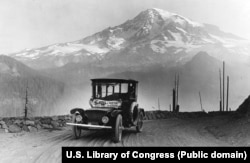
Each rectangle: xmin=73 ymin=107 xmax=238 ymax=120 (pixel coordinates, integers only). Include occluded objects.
xmin=93 ymin=83 xmax=128 ymax=100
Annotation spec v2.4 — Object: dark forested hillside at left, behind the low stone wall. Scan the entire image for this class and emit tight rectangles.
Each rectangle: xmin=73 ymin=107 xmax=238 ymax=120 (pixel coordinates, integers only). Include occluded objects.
xmin=0 ymin=55 xmax=64 ymax=116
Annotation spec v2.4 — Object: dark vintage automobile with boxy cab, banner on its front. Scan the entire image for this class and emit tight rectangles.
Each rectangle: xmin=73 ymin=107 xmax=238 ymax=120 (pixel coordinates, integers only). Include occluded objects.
xmin=67 ymin=78 xmax=145 ymax=143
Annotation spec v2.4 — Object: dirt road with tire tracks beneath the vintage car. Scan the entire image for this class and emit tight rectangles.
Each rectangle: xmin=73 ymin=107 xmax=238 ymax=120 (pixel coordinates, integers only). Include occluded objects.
xmin=0 ymin=117 xmax=250 ymax=163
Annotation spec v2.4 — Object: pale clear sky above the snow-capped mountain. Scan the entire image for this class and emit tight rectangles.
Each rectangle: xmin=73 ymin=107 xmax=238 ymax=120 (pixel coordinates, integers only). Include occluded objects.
xmin=0 ymin=0 xmax=250 ymax=54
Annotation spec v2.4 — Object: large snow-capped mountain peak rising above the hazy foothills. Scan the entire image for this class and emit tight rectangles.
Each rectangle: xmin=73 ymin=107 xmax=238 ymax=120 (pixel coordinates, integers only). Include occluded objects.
xmin=6 ymin=8 xmax=250 ymax=69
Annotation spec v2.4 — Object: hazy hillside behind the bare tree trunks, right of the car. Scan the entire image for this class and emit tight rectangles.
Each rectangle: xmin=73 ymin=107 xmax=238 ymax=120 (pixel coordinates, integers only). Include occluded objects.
xmin=106 ymin=52 xmax=250 ymax=111
